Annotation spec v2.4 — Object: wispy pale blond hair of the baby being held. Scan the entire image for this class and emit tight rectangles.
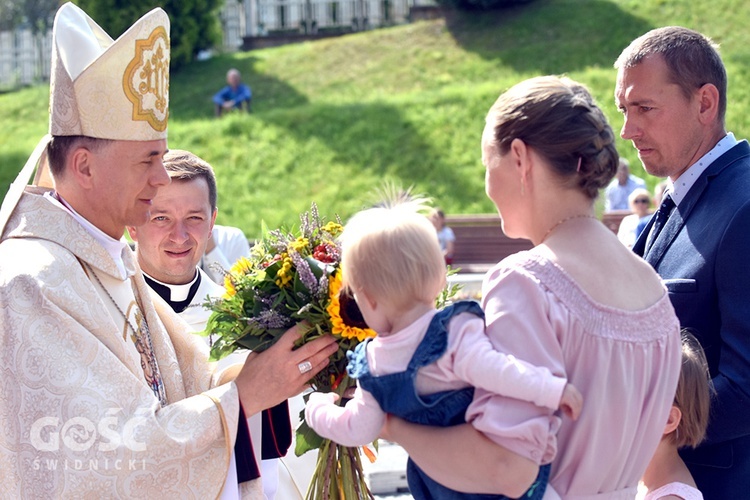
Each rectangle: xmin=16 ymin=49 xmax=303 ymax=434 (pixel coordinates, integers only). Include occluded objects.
xmin=341 ymin=199 xmax=446 ymax=310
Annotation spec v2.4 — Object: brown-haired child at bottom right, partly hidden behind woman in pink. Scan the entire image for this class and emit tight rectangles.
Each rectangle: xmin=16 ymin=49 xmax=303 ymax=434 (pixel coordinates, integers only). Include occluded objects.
xmin=643 ymin=331 xmax=713 ymax=500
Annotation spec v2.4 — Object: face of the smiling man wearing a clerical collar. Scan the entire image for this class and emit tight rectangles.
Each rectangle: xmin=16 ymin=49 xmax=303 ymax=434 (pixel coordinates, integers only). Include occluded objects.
xmin=128 ymin=177 xmax=216 ymax=285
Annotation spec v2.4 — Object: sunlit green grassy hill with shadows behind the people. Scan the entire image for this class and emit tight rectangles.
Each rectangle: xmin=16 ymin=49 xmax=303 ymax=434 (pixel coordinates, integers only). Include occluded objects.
xmin=0 ymin=0 xmax=750 ymax=236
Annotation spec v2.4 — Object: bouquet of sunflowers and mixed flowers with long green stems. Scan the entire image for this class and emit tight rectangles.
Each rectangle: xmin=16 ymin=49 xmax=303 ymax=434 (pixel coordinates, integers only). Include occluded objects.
xmin=206 ymin=204 xmax=375 ymax=500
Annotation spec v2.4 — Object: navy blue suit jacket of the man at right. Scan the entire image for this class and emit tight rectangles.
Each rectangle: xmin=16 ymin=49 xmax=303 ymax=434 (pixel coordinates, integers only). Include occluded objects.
xmin=633 ymin=141 xmax=750 ymax=500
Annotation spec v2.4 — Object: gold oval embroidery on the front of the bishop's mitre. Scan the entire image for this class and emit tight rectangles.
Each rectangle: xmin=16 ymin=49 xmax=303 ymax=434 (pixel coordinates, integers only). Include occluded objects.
xmin=122 ymin=26 xmax=169 ymax=132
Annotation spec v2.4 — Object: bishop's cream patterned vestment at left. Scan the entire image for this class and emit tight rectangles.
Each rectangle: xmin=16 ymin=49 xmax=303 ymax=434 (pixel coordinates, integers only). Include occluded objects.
xmin=0 ymin=188 xmax=260 ymax=499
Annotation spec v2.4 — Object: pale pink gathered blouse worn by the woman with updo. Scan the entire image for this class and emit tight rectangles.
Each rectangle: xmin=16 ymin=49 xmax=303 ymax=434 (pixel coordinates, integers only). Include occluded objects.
xmin=467 ymin=254 xmax=681 ymax=499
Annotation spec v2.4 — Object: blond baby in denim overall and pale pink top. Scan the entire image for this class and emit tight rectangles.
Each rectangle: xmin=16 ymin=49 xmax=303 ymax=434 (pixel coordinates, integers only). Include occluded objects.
xmin=305 ymin=201 xmax=582 ymax=500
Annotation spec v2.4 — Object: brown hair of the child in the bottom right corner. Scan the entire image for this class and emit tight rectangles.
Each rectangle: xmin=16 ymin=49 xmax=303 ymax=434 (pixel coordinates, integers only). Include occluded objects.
xmin=670 ymin=330 xmax=713 ymax=448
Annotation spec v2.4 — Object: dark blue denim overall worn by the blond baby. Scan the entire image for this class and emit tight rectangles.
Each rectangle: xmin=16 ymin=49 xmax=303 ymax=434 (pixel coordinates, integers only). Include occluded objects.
xmin=347 ymin=300 xmax=550 ymax=500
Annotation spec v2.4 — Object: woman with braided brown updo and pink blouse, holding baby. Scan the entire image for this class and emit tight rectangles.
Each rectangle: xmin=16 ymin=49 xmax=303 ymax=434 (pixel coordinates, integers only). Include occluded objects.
xmin=384 ymin=76 xmax=680 ymax=500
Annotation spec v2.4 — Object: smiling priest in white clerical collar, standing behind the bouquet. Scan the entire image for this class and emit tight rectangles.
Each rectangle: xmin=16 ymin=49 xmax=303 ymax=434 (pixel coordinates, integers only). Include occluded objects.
xmin=128 ymin=149 xmax=314 ymax=500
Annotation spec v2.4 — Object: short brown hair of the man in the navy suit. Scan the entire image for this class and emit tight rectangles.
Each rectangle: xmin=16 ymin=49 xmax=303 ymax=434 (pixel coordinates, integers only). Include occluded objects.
xmin=615 ymin=26 xmax=727 ymax=124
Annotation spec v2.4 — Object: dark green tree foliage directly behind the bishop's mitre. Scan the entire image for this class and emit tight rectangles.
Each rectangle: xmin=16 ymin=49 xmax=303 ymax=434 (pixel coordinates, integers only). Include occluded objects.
xmin=74 ymin=0 xmax=223 ymax=68
